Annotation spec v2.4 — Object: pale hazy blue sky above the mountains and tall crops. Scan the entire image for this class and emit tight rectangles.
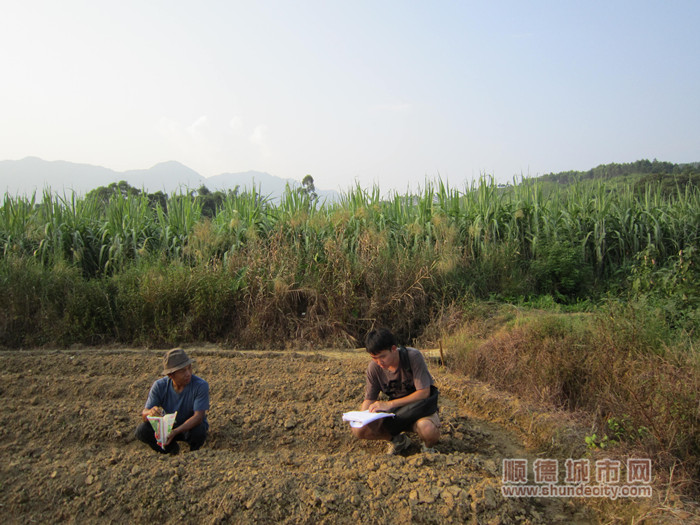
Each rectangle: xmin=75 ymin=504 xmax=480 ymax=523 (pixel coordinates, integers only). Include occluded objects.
xmin=0 ymin=0 xmax=700 ymax=193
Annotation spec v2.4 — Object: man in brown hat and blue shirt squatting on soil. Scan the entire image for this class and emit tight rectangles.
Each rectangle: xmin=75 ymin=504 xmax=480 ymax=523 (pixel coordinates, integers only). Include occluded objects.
xmin=136 ymin=348 xmax=209 ymax=454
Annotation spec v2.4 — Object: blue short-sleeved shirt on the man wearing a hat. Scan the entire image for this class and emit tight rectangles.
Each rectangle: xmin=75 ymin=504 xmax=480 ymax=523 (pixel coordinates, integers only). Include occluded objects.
xmin=146 ymin=375 xmax=209 ymax=429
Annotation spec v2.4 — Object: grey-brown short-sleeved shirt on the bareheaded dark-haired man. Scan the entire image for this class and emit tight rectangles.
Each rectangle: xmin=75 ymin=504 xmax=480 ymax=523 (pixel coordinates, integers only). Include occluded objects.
xmin=365 ymin=347 xmax=433 ymax=401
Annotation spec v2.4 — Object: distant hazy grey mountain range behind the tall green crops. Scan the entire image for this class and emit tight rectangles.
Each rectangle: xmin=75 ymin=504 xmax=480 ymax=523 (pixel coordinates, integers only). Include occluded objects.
xmin=0 ymin=157 xmax=339 ymax=200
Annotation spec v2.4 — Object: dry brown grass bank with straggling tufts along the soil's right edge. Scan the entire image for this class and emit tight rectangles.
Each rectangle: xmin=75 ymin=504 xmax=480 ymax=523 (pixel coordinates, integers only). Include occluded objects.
xmin=445 ymin=302 xmax=700 ymax=512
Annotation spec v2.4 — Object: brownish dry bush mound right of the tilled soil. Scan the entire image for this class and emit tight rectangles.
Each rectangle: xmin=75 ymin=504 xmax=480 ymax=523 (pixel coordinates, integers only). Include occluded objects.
xmin=450 ymin=302 xmax=700 ymax=494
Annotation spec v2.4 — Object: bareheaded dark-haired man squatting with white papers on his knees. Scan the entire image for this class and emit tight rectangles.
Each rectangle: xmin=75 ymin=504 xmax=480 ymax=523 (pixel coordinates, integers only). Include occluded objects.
xmin=351 ymin=328 xmax=440 ymax=454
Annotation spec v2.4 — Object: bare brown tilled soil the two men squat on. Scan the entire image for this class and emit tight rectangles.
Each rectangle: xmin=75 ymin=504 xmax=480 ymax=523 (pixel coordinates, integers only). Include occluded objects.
xmin=0 ymin=348 xmax=628 ymax=524
